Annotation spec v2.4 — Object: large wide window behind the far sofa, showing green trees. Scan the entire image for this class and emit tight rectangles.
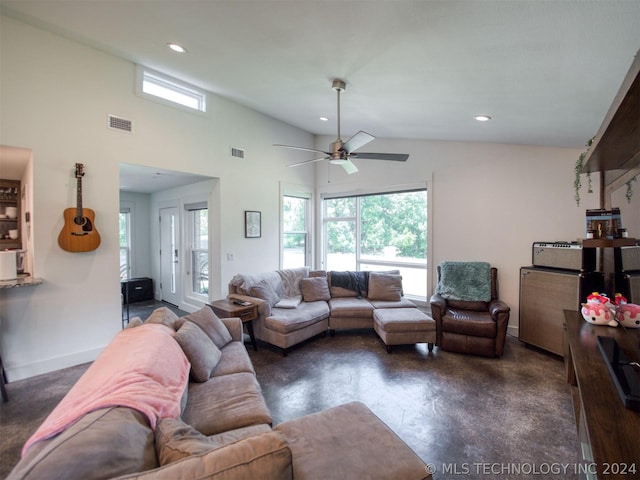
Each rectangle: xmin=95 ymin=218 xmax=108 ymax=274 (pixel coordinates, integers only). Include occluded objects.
xmin=323 ymin=189 xmax=427 ymax=300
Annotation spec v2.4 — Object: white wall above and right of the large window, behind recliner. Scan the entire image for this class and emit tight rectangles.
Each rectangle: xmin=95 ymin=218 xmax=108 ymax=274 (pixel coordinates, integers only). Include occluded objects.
xmin=316 ymin=132 xmax=604 ymax=335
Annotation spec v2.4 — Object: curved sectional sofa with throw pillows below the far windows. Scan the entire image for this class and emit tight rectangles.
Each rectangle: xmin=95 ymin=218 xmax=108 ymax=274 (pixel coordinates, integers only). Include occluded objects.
xmin=228 ymin=268 xmax=424 ymax=355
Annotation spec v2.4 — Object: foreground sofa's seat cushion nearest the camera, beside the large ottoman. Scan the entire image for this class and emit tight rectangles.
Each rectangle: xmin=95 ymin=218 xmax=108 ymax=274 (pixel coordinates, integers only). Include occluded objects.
xmin=182 ymin=372 xmax=273 ymax=435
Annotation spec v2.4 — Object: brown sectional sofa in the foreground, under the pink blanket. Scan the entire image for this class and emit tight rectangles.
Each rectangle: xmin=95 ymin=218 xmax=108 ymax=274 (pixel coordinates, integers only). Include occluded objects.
xmin=8 ymin=307 xmax=431 ymax=480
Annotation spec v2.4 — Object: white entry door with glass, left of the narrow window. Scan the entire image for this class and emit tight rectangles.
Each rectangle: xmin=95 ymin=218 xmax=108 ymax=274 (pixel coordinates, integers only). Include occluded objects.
xmin=160 ymin=207 xmax=180 ymax=305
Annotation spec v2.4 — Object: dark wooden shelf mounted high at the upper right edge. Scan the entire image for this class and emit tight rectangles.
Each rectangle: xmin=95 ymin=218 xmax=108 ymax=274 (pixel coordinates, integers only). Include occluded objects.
xmin=582 ymin=52 xmax=640 ymax=187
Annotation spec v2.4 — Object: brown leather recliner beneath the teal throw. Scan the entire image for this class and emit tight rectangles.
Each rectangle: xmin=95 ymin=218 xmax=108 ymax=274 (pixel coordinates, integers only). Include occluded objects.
xmin=431 ymin=266 xmax=511 ymax=357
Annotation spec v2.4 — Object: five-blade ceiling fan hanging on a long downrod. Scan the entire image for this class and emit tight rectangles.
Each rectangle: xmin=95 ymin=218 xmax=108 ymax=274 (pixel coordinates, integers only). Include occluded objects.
xmin=274 ymin=79 xmax=409 ymax=175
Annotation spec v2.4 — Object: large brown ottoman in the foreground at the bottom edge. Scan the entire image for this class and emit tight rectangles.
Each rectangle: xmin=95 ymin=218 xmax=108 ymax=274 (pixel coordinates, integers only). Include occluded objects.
xmin=274 ymin=402 xmax=432 ymax=480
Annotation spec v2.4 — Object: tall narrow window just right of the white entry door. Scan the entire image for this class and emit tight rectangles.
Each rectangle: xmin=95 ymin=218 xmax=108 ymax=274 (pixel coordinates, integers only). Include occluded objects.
xmin=185 ymin=202 xmax=209 ymax=295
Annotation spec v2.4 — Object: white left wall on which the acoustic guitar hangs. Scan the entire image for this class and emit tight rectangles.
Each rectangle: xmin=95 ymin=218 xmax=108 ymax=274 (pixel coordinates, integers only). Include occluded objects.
xmin=0 ymin=17 xmax=314 ymax=380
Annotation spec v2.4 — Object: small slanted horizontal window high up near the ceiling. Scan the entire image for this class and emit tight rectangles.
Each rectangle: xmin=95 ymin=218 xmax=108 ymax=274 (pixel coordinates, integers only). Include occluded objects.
xmin=138 ymin=67 xmax=207 ymax=112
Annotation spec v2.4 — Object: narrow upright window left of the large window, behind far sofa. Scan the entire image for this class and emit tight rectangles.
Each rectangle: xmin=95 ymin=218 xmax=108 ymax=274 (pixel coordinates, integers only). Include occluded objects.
xmin=282 ymin=195 xmax=311 ymax=268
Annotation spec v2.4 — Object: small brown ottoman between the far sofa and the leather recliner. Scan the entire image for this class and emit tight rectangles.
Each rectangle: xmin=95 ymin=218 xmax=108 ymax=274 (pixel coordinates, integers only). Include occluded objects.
xmin=373 ymin=308 xmax=436 ymax=353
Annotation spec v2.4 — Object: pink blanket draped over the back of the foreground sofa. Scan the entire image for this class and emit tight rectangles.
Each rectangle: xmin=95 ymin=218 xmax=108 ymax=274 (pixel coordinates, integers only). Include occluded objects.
xmin=22 ymin=324 xmax=190 ymax=455
